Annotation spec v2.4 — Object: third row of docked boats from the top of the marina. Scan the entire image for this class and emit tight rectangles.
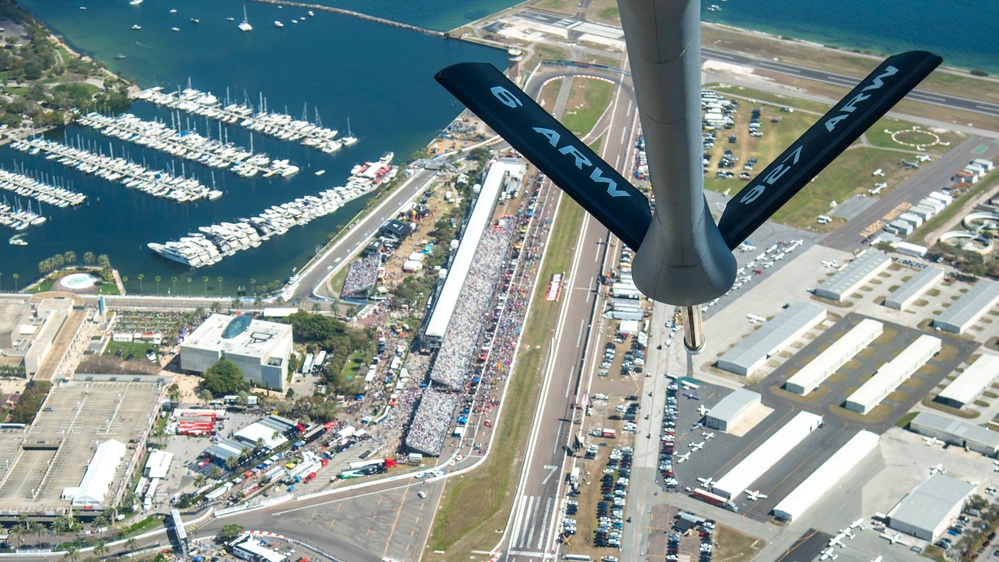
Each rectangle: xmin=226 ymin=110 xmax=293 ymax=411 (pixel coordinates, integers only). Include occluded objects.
xmin=10 ymin=137 xmax=222 ymax=203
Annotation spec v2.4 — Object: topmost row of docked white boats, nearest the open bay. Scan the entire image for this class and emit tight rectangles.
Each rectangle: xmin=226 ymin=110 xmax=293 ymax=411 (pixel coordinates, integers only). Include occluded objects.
xmin=129 ymin=87 xmax=357 ymax=154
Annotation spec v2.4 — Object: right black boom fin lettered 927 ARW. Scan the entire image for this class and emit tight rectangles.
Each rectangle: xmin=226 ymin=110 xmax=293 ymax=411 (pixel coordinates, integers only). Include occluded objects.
xmin=718 ymin=51 xmax=943 ymax=250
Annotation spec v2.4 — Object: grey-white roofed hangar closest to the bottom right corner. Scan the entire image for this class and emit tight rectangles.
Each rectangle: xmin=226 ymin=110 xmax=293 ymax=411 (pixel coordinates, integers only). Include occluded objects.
xmin=888 ymin=474 xmax=976 ymax=542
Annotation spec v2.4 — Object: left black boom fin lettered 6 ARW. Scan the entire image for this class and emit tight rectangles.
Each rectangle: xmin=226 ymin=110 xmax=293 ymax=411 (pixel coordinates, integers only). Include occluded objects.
xmin=435 ymin=63 xmax=652 ymax=250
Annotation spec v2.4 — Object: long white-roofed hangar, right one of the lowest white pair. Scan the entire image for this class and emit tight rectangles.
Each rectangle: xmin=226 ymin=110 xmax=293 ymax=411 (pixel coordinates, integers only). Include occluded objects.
xmin=774 ymin=431 xmax=880 ymax=521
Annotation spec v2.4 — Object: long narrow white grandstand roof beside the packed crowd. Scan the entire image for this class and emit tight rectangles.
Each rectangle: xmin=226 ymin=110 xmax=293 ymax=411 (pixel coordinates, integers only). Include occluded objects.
xmin=426 ymin=158 xmax=525 ymax=338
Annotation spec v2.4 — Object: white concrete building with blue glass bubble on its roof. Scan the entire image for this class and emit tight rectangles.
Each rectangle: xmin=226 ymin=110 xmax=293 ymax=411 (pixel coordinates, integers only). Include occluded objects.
xmin=180 ymin=314 xmax=292 ymax=391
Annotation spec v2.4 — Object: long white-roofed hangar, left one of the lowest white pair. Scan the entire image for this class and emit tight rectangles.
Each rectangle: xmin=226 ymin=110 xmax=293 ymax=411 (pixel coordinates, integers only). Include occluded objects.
xmin=711 ymin=412 xmax=822 ymax=499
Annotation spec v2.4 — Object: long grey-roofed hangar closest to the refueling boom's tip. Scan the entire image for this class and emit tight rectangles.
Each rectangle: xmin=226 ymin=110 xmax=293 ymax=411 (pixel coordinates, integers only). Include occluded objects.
xmin=717 ymin=302 xmax=826 ymax=376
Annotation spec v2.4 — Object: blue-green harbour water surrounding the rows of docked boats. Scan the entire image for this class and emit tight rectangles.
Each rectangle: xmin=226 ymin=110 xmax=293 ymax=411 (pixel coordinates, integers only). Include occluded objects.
xmin=0 ymin=0 xmax=505 ymax=295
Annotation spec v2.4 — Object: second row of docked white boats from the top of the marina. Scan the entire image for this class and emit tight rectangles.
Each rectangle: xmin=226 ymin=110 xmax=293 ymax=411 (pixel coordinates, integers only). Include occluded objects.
xmin=77 ymin=112 xmax=299 ymax=178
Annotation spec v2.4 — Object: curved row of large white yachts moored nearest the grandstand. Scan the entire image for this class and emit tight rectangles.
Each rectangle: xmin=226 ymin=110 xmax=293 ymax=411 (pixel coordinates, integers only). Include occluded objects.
xmin=147 ymin=153 xmax=397 ymax=269
